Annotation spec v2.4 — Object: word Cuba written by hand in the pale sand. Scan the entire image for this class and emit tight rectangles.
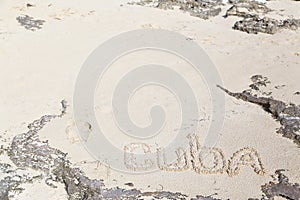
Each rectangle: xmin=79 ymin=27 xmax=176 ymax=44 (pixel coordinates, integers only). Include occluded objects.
xmin=124 ymin=135 xmax=265 ymax=176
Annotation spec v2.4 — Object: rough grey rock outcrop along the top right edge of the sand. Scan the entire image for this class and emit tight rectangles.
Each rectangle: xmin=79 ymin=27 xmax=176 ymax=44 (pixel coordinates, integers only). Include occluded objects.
xmin=129 ymin=0 xmax=300 ymax=34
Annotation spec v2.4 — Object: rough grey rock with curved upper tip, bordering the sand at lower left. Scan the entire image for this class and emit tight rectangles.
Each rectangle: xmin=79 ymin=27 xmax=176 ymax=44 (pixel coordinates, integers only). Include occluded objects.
xmin=0 ymin=101 xmax=187 ymax=200
